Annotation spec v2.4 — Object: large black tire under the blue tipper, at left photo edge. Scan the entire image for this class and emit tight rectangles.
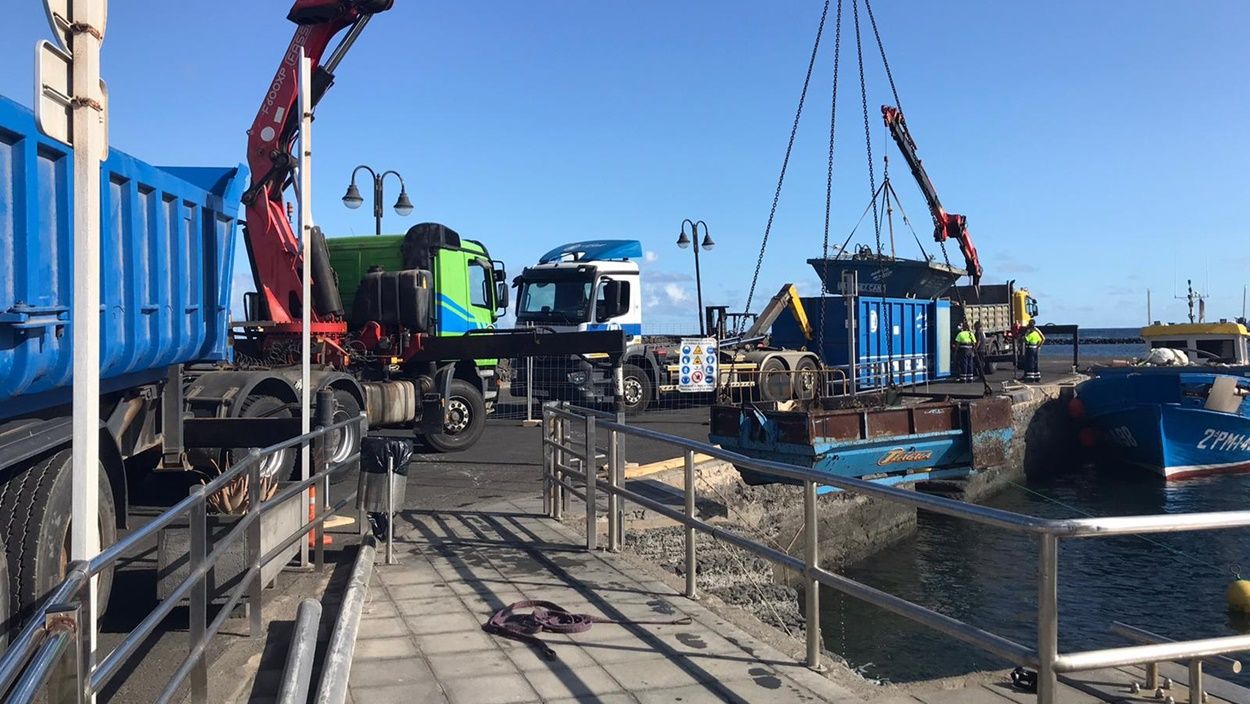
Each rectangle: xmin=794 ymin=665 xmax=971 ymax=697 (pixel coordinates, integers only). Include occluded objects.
xmin=0 ymin=449 xmax=118 ymax=633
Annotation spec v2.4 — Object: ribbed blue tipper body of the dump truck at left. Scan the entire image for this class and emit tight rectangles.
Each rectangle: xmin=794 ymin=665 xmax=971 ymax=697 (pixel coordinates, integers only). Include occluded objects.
xmin=0 ymin=98 xmax=246 ymax=418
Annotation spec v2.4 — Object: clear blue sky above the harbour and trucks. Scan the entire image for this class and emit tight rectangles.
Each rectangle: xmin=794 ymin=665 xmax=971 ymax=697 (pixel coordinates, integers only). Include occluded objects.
xmin=0 ymin=0 xmax=1250 ymax=326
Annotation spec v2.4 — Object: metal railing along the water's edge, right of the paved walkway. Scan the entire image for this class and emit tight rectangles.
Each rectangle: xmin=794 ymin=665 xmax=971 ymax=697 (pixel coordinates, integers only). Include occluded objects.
xmin=543 ymin=403 xmax=1250 ymax=704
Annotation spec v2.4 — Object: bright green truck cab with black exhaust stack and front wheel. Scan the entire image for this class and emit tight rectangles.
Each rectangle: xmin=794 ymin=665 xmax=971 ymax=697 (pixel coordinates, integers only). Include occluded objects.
xmin=326 ymin=225 xmax=509 ymax=451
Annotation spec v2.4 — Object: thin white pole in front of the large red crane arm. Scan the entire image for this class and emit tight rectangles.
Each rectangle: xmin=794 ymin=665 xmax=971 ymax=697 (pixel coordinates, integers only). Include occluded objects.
xmin=299 ymin=49 xmax=313 ymax=566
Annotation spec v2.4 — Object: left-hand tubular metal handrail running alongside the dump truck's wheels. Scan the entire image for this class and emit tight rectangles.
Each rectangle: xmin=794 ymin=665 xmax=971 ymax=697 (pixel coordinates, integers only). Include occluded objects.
xmin=0 ymin=391 xmax=368 ymax=704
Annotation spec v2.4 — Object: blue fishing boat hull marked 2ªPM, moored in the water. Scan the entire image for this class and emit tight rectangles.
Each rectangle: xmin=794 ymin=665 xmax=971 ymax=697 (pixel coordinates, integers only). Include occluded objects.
xmin=1074 ymin=366 xmax=1250 ymax=480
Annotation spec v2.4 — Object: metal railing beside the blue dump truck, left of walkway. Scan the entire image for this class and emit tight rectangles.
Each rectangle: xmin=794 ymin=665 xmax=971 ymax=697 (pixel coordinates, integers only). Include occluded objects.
xmin=0 ymin=401 xmax=366 ymax=704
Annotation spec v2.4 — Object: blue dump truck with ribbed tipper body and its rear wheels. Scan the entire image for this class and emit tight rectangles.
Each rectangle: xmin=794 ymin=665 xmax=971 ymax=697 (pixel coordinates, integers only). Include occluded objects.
xmin=0 ymin=98 xmax=277 ymax=630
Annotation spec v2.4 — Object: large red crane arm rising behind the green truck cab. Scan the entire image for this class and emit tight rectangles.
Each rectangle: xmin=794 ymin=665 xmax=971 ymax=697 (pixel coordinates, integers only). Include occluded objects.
xmin=243 ymin=0 xmax=394 ymax=324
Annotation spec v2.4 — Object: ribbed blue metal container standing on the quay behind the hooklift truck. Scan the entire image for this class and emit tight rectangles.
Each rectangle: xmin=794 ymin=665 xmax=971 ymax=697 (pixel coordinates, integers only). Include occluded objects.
xmin=773 ymin=296 xmax=950 ymax=389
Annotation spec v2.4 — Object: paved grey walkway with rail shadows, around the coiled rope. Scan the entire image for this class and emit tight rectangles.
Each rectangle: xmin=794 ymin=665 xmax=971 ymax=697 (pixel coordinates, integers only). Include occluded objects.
xmin=350 ymin=499 xmax=861 ymax=704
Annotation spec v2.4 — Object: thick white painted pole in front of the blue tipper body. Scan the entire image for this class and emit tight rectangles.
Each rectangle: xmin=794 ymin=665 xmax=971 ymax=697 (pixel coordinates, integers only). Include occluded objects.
xmin=70 ymin=0 xmax=106 ymax=675
